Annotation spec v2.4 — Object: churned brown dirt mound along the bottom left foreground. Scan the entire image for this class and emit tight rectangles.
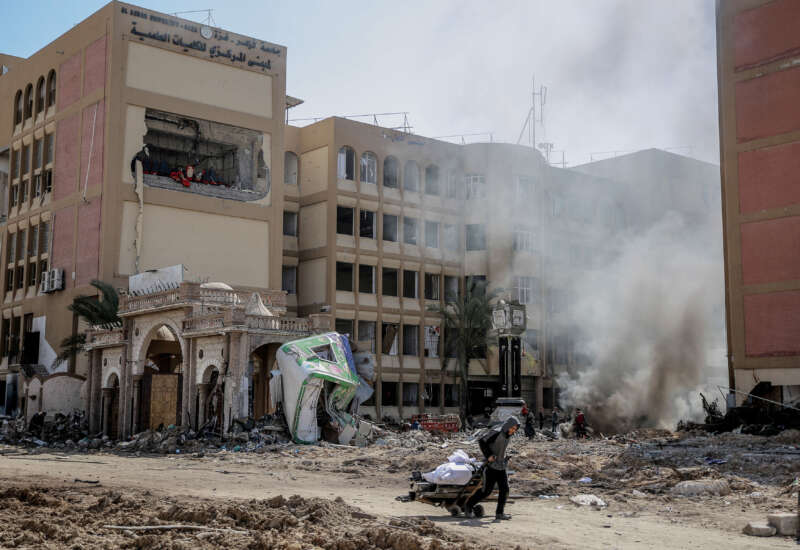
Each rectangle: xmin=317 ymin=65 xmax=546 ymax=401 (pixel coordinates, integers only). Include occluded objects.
xmin=0 ymin=486 xmax=500 ymax=550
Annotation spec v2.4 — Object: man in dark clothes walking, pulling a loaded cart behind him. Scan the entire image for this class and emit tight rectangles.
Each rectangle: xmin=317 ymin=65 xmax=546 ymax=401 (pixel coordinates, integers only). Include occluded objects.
xmin=466 ymin=416 xmax=519 ymax=519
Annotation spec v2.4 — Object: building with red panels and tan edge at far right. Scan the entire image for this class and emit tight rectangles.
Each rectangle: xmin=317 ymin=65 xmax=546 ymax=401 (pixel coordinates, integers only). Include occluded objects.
xmin=717 ymin=0 xmax=800 ymax=403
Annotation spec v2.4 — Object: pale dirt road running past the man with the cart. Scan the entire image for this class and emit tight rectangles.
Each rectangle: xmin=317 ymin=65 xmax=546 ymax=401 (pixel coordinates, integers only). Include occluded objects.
xmin=0 ymin=451 xmax=795 ymax=549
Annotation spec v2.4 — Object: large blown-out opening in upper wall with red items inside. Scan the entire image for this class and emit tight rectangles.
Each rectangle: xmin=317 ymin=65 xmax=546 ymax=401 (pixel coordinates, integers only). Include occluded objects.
xmin=140 ymin=109 xmax=270 ymax=200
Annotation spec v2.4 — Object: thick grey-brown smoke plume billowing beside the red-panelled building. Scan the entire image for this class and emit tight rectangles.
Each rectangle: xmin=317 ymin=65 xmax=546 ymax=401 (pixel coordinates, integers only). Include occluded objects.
xmin=558 ymin=213 xmax=724 ymax=433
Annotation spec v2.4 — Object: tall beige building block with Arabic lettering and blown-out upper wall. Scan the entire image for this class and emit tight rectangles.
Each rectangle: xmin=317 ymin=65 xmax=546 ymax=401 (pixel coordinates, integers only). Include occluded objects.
xmin=0 ymin=2 xmax=291 ymax=426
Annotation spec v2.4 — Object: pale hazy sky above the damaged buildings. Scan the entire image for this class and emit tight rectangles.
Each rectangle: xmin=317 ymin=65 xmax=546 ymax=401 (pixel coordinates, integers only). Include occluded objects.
xmin=0 ymin=0 xmax=719 ymax=165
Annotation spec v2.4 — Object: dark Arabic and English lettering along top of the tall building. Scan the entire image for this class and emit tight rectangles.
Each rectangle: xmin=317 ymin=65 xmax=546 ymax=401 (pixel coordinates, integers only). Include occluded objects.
xmin=120 ymin=5 xmax=285 ymax=72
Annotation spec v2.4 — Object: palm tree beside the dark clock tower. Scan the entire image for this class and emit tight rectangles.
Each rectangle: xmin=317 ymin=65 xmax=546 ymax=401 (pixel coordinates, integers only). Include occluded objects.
xmin=428 ymin=280 xmax=497 ymax=421
